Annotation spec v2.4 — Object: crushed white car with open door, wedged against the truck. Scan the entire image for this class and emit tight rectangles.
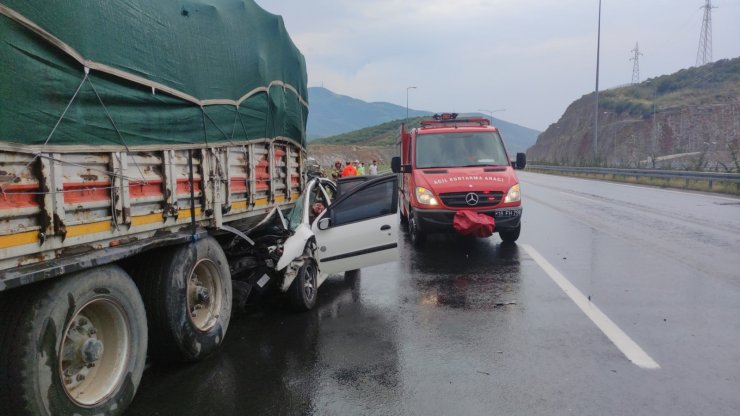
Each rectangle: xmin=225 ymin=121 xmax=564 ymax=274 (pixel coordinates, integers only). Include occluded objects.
xmin=227 ymin=174 xmax=399 ymax=310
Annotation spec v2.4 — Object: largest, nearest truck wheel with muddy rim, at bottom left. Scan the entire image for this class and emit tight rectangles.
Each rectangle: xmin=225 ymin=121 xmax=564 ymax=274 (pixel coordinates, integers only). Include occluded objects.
xmin=0 ymin=266 xmax=147 ymax=415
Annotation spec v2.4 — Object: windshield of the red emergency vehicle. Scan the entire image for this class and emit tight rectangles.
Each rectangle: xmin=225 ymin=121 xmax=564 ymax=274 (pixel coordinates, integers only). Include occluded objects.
xmin=416 ymin=132 xmax=509 ymax=168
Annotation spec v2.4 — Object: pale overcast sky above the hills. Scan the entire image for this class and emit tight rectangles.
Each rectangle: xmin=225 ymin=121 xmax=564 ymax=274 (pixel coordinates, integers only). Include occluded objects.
xmin=256 ymin=0 xmax=740 ymax=130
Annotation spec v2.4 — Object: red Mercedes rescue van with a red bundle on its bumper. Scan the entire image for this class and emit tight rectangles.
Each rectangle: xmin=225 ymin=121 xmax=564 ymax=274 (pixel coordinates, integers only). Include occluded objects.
xmin=392 ymin=113 xmax=526 ymax=245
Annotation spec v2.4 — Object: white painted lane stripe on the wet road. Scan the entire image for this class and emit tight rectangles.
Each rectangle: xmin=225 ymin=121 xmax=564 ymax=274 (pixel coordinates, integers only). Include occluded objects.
xmin=521 ymin=244 xmax=660 ymax=369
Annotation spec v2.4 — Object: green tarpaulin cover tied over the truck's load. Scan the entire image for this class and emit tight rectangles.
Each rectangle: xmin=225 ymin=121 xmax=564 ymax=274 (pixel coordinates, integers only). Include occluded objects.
xmin=0 ymin=0 xmax=308 ymax=152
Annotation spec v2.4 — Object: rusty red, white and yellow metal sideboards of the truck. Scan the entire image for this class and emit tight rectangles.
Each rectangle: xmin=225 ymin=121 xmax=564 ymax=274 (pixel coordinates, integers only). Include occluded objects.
xmin=0 ymin=140 xmax=305 ymax=280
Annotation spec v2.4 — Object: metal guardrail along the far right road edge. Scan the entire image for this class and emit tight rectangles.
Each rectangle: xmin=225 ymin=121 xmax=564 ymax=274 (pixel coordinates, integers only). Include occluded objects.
xmin=527 ymin=165 xmax=740 ymax=183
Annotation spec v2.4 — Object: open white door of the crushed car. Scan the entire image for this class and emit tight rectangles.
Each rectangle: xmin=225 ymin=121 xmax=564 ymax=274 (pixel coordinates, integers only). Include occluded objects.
xmin=312 ymin=174 xmax=399 ymax=274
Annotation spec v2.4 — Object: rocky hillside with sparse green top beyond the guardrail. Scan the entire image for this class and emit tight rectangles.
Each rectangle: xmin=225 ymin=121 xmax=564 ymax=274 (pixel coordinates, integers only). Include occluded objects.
xmin=527 ymin=58 xmax=740 ymax=171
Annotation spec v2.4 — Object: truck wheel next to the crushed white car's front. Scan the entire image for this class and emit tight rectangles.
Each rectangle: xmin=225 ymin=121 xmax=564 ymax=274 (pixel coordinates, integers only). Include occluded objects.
xmin=136 ymin=237 xmax=232 ymax=362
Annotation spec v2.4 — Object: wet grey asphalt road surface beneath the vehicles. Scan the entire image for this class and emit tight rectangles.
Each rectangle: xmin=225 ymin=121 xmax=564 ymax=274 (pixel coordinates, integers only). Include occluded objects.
xmin=127 ymin=172 xmax=740 ymax=416
